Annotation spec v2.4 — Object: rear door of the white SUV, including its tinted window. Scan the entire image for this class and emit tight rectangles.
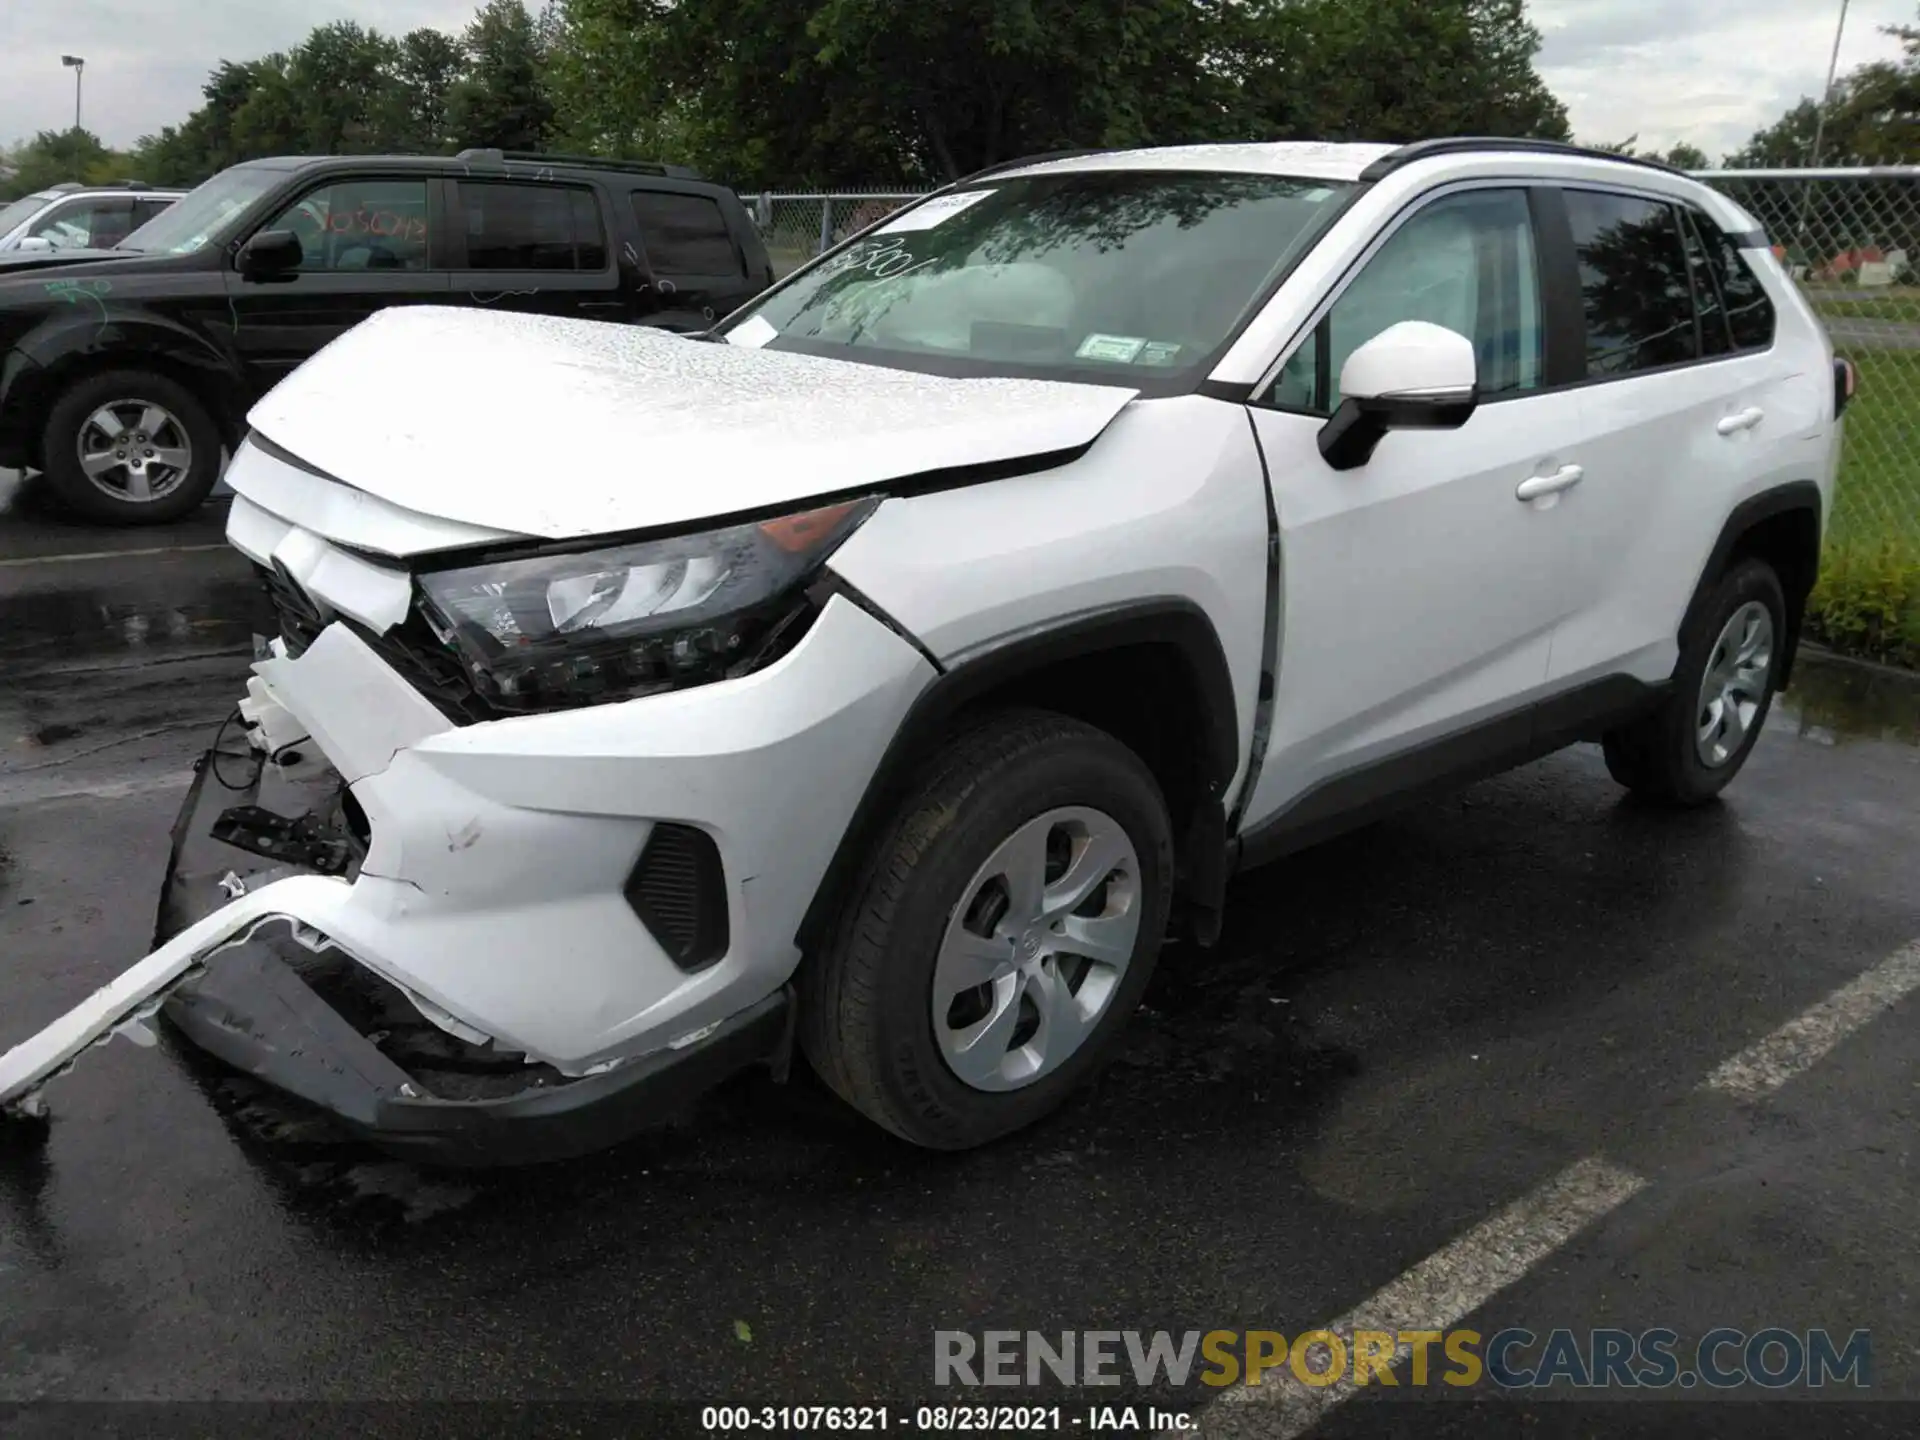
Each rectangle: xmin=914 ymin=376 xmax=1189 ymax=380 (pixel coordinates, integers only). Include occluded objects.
xmin=1548 ymin=186 xmax=1788 ymax=689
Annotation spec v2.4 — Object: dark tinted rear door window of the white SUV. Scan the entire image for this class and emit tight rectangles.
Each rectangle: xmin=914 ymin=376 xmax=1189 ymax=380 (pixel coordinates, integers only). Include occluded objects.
xmin=1565 ymin=190 xmax=1699 ymax=378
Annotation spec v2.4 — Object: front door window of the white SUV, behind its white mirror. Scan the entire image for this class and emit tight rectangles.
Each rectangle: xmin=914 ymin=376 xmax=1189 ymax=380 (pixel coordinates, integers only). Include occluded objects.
xmin=1265 ymin=190 xmax=1544 ymax=415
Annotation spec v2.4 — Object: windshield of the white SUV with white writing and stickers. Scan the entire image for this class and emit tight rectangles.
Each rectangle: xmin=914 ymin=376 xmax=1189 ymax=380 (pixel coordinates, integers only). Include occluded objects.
xmin=726 ymin=171 xmax=1350 ymax=384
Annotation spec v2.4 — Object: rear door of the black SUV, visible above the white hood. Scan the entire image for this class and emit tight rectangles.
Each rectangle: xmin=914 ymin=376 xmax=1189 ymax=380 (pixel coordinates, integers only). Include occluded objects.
xmin=441 ymin=179 xmax=628 ymax=321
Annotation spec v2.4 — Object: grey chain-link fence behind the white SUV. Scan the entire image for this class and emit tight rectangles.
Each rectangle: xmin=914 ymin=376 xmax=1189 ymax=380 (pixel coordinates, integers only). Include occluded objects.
xmin=741 ymin=165 xmax=1920 ymax=553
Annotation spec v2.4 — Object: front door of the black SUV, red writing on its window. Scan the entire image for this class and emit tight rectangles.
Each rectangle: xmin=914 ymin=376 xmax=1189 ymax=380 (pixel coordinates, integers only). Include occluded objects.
xmin=227 ymin=175 xmax=449 ymax=396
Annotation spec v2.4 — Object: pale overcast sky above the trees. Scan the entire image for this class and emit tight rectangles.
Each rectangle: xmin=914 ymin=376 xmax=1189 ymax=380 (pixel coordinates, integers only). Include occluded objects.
xmin=0 ymin=0 xmax=1920 ymax=159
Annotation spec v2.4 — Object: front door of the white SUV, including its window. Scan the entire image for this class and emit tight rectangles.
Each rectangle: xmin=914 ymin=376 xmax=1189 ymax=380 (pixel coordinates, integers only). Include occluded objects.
xmin=1242 ymin=188 xmax=1580 ymax=828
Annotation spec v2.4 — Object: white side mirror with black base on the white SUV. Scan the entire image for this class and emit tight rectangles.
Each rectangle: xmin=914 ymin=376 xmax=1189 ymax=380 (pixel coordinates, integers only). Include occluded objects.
xmin=1319 ymin=321 xmax=1480 ymax=470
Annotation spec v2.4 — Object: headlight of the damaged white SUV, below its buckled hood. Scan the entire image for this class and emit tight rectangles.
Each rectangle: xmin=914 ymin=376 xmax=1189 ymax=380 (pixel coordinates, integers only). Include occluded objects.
xmin=419 ymin=499 xmax=877 ymax=710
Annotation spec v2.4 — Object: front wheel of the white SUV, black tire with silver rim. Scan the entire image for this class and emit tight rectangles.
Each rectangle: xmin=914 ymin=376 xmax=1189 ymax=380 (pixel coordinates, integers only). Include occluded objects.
xmin=799 ymin=710 xmax=1173 ymax=1150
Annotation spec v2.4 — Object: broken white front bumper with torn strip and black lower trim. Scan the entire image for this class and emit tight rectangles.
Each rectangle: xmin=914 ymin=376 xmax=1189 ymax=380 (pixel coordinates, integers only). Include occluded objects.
xmin=0 ymin=576 xmax=927 ymax=1165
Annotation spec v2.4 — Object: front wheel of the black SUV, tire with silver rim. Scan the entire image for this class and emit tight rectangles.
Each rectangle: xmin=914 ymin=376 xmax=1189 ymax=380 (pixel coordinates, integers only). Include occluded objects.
xmin=40 ymin=371 xmax=221 ymax=524
